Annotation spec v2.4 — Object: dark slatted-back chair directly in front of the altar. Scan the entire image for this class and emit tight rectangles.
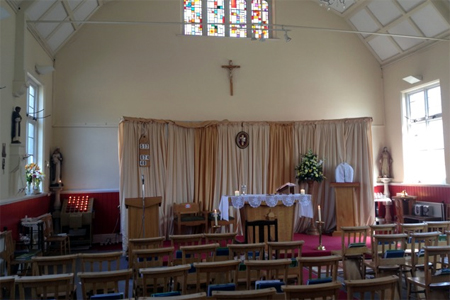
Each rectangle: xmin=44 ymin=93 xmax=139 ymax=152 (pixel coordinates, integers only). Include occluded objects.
xmin=244 ymin=219 xmax=278 ymax=244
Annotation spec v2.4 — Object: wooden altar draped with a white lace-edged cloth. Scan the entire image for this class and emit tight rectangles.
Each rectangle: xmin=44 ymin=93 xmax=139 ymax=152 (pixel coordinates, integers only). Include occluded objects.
xmin=219 ymin=194 xmax=313 ymax=241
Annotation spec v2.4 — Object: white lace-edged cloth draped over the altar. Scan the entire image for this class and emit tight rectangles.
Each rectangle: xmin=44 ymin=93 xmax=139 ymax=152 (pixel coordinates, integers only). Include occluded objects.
xmin=219 ymin=194 xmax=313 ymax=221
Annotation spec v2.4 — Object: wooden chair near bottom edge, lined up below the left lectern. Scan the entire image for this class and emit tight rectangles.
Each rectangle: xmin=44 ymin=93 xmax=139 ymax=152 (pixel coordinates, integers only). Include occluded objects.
xmin=138 ymin=264 xmax=191 ymax=297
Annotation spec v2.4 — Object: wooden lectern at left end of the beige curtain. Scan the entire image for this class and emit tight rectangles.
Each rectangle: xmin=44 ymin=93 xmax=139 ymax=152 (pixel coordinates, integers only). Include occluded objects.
xmin=125 ymin=197 xmax=162 ymax=239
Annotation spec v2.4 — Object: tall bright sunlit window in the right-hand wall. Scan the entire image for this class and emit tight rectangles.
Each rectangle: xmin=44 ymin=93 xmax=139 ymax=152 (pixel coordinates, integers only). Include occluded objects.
xmin=403 ymin=83 xmax=446 ymax=184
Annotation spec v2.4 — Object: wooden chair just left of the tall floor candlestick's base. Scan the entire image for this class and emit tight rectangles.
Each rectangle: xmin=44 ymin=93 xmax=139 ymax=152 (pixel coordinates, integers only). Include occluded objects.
xmin=267 ymin=241 xmax=305 ymax=284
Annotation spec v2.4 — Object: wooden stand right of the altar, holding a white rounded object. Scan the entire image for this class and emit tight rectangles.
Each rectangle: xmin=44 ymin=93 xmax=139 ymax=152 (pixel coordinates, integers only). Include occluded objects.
xmin=330 ymin=182 xmax=359 ymax=236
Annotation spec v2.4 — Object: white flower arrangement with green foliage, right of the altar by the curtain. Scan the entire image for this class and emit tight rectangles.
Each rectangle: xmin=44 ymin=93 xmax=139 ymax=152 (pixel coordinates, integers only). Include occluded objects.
xmin=295 ymin=149 xmax=326 ymax=183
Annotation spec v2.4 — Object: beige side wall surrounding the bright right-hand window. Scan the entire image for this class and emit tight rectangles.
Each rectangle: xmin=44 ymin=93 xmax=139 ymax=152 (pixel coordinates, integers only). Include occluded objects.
xmin=384 ymin=42 xmax=450 ymax=184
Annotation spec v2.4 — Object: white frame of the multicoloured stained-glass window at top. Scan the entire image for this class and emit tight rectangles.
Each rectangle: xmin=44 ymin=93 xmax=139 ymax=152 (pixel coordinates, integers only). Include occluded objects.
xmin=181 ymin=0 xmax=274 ymax=39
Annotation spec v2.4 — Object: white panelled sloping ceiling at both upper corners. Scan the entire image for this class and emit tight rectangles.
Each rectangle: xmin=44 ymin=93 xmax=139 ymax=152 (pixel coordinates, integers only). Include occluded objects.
xmin=4 ymin=0 xmax=450 ymax=65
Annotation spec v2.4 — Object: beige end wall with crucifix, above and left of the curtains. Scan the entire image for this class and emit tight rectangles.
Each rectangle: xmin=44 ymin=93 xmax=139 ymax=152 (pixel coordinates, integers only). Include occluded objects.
xmin=53 ymin=1 xmax=384 ymax=189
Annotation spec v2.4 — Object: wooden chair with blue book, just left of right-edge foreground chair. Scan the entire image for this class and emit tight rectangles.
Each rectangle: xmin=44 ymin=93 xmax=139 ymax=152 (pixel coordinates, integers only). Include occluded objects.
xmin=363 ymin=233 xmax=408 ymax=297
